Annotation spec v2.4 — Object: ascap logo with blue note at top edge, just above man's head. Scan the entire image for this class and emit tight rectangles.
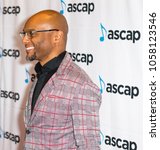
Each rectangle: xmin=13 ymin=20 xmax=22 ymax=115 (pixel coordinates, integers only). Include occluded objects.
xmin=60 ymin=0 xmax=95 ymax=15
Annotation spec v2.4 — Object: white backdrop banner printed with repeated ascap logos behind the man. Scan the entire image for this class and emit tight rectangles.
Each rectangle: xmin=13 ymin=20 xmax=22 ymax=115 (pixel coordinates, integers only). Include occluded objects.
xmin=0 ymin=0 xmax=143 ymax=150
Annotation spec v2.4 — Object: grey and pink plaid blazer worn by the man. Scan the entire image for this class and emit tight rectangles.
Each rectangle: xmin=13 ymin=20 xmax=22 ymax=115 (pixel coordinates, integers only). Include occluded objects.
xmin=24 ymin=53 xmax=101 ymax=150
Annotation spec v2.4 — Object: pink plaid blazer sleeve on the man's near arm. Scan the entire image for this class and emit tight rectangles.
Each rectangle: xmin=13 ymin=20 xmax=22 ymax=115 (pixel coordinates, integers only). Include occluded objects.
xmin=71 ymin=83 xmax=101 ymax=150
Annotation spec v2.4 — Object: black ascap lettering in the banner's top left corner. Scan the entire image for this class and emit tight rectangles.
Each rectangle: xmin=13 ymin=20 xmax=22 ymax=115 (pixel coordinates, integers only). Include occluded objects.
xmin=3 ymin=6 xmax=21 ymax=16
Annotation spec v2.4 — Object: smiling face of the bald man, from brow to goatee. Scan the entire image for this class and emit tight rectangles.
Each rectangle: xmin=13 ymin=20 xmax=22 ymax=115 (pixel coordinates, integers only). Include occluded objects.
xmin=22 ymin=23 xmax=53 ymax=61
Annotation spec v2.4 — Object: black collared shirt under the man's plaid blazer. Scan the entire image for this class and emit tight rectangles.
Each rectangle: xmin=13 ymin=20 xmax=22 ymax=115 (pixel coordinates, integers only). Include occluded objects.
xmin=31 ymin=51 xmax=66 ymax=114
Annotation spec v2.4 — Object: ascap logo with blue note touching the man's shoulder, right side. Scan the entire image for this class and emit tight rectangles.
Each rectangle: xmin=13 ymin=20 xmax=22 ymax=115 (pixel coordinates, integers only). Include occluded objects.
xmin=99 ymin=76 xmax=139 ymax=99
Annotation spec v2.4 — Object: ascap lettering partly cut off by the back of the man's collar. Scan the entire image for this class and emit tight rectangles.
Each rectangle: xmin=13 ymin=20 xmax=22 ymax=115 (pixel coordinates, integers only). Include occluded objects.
xmin=69 ymin=53 xmax=93 ymax=65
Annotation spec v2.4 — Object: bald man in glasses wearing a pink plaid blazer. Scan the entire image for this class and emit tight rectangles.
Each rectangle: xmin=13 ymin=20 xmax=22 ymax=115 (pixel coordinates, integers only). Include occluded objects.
xmin=20 ymin=10 xmax=101 ymax=150
